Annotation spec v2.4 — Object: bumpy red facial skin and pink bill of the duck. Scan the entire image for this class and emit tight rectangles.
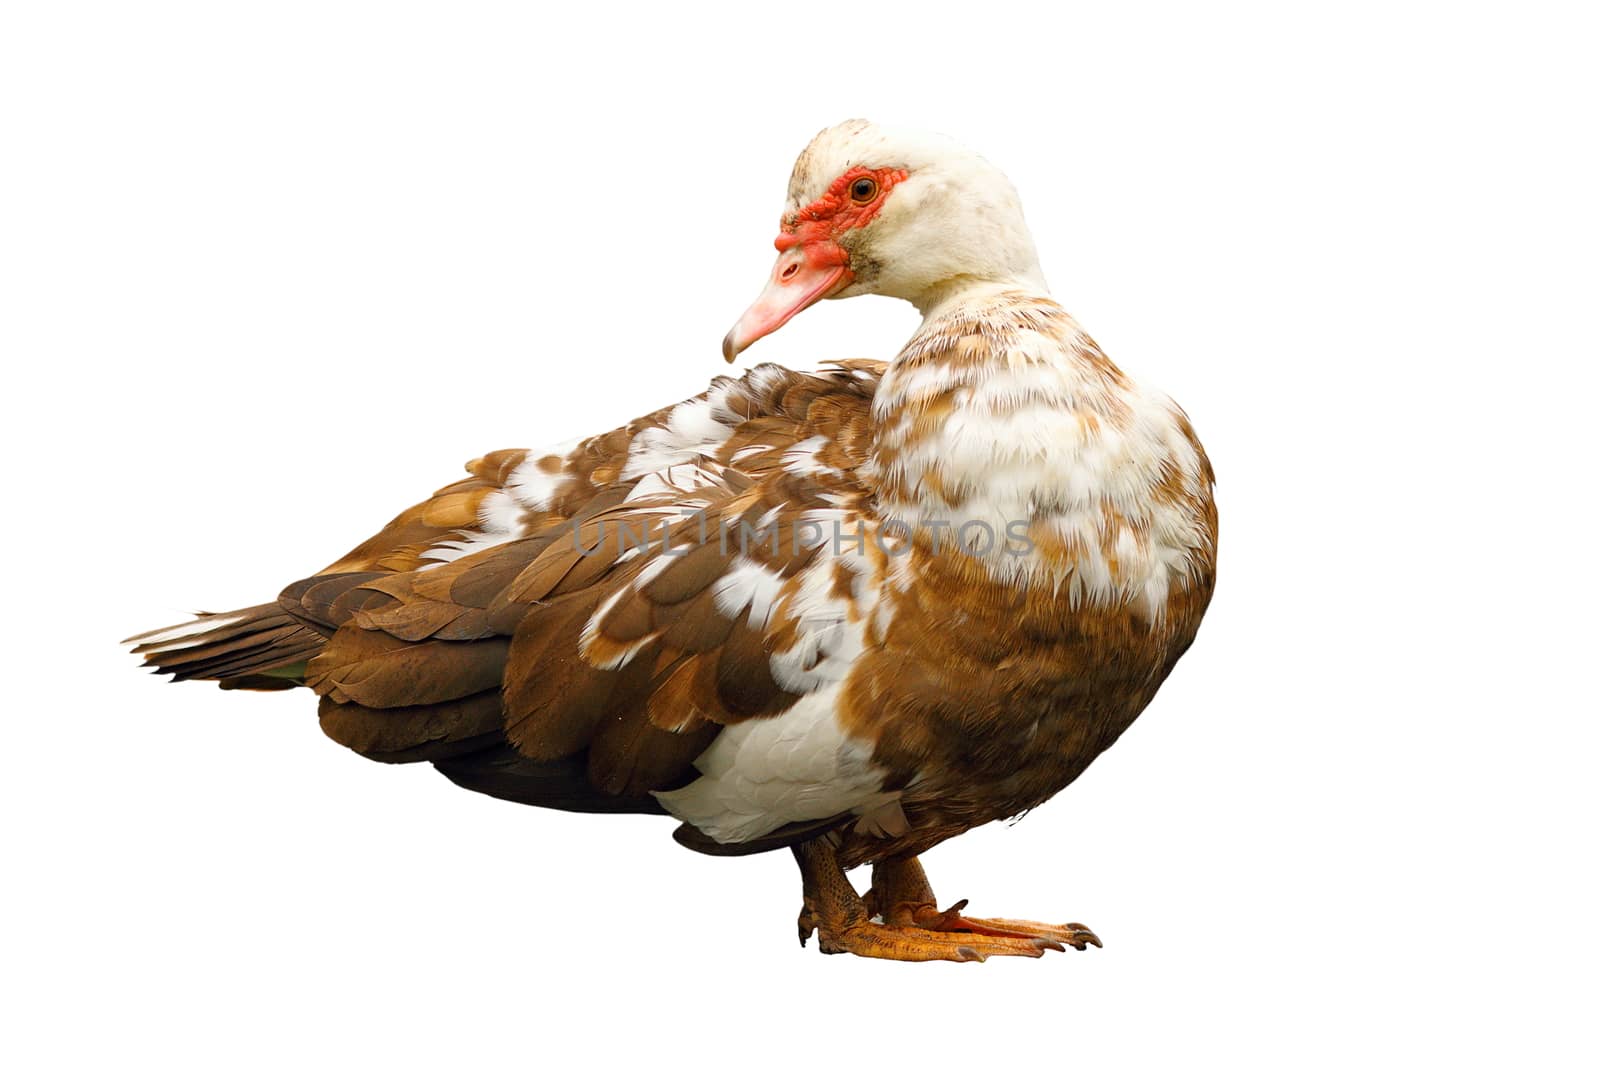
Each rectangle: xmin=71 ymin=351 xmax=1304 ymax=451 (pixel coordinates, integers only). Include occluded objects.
xmin=722 ymin=166 xmax=906 ymax=363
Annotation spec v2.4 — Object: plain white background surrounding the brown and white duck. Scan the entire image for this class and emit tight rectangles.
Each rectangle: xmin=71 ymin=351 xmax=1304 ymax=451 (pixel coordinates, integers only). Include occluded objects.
xmin=0 ymin=2 xmax=1600 ymax=1064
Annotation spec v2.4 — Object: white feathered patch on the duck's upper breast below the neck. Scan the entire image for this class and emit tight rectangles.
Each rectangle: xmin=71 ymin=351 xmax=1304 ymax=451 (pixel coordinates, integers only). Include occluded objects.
xmin=874 ymin=310 xmax=1206 ymax=607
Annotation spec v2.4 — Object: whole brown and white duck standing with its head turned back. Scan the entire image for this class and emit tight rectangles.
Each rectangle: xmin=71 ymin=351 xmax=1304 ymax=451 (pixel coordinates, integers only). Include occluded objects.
xmin=130 ymin=120 xmax=1218 ymax=961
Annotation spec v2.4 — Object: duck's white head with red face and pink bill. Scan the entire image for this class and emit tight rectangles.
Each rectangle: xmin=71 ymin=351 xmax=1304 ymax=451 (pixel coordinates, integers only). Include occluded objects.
xmin=722 ymin=118 xmax=1045 ymax=363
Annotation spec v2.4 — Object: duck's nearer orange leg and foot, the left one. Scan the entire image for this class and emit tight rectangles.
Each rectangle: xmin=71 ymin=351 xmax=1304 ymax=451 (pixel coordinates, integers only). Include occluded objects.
xmin=794 ymin=838 xmax=1061 ymax=961
